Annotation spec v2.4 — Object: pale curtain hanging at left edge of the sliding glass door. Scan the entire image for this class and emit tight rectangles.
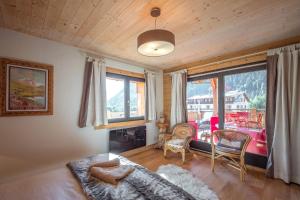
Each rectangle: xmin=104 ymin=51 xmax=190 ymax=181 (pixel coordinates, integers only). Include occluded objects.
xmin=170 ymin=70 xmax=187 ymax=127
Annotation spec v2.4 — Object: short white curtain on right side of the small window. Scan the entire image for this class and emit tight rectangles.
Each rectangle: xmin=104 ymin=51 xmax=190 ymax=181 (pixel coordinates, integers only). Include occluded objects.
xmin=145 ymin=70 xmax=156 ymax=121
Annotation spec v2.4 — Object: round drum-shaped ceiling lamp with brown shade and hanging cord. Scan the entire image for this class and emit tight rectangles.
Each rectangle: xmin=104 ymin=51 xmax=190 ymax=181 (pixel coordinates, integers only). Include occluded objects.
xmin=137 ymin=7 xmax=175 ymax=56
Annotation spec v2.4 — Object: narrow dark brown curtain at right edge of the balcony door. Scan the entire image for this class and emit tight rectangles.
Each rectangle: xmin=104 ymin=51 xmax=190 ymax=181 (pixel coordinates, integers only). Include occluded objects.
xmin=265 ymin=54 xmax=278 ymax=177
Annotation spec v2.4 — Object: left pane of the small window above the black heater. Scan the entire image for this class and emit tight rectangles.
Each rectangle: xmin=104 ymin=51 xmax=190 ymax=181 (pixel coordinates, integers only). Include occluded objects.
xmin=106 ymin=77 xmax=125 ymax=119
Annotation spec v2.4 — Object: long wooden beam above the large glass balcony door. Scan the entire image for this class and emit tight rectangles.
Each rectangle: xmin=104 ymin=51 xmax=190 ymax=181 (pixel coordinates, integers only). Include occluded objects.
xmin=164 ymin=35 xmax=300 ymax=73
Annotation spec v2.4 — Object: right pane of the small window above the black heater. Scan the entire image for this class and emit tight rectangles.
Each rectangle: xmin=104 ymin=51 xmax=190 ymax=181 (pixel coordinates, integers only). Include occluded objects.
xmin=129 ymin=81 xmax=145 ymax=117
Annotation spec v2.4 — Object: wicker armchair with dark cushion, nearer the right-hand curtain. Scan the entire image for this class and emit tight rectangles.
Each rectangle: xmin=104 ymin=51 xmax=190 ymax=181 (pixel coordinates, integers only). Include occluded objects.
xmin=211 ymin=130 xmax=251 ymax=181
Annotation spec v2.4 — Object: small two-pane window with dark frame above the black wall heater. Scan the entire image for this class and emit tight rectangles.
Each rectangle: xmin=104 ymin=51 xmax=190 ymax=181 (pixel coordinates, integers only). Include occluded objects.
xmin=106 ymin=73 xmax=145 ymax=123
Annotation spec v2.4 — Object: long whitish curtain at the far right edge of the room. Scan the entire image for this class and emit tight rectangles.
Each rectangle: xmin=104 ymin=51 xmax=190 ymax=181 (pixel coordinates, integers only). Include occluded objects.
xmin=268 ymin=44 xmax=300 ymax=184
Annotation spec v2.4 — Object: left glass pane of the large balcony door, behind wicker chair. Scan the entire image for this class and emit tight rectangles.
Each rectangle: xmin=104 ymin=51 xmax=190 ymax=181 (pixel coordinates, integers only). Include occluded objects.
xmin=187 ymin=78 xmax=219 ymax=143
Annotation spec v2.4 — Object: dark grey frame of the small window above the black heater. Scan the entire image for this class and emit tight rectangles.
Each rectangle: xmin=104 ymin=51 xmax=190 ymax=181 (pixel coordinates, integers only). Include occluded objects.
xmin=106 ymin=72 xmax=145 ymax=123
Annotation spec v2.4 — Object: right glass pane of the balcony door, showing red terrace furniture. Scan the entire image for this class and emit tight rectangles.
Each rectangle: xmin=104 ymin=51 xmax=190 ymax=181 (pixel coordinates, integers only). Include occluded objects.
xmin=224 ymin=70 xmax=267 ymax=156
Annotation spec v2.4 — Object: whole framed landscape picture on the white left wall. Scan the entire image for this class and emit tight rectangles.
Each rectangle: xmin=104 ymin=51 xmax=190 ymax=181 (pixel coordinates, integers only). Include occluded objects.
xmin=0 ymin=58 xmax=53 ymax=116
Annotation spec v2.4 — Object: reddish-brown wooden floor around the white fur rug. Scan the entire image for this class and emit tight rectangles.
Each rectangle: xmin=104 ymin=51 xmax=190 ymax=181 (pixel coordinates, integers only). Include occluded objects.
xmin=127 ymin=149 xmax=300 ymax=200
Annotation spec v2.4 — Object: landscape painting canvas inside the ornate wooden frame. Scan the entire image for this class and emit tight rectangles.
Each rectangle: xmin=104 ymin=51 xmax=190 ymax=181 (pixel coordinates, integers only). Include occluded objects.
xmin=7 ymin=65 xmax=47 ymax=111
